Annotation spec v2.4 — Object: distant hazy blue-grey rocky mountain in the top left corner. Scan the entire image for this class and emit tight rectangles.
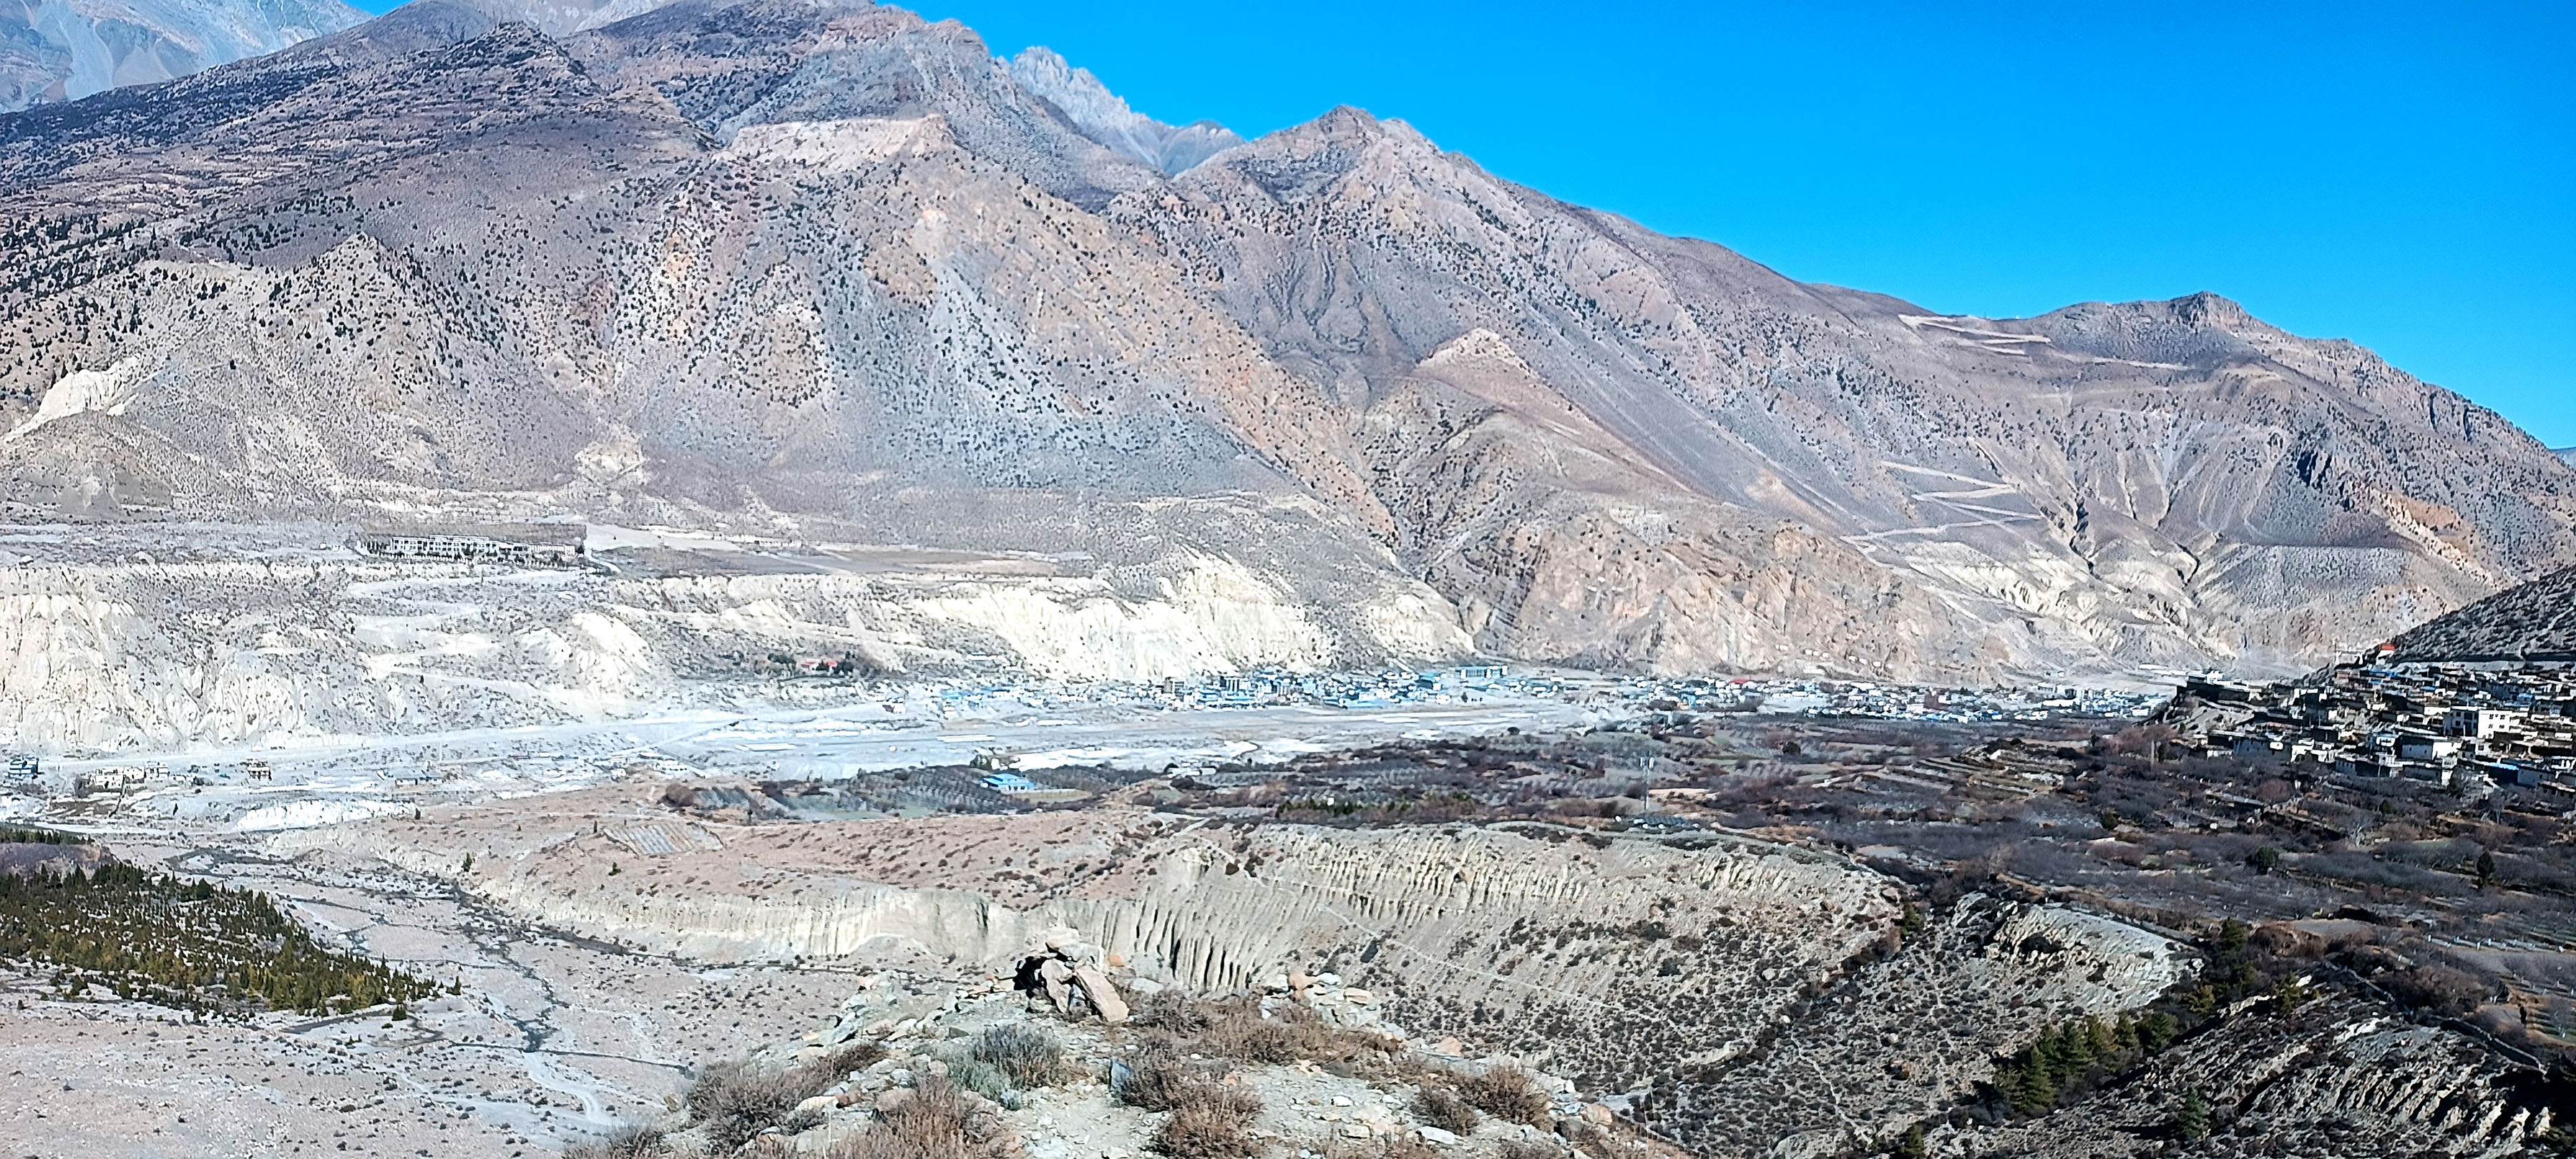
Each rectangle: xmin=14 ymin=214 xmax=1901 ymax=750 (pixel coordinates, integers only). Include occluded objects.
xmin=0 ymin=0 xmax=366 ymax=113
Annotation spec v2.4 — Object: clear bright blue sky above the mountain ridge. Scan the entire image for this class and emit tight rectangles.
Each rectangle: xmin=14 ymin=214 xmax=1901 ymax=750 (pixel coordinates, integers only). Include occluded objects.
xmin=363 ymin=0 xmax=2576 ymax=446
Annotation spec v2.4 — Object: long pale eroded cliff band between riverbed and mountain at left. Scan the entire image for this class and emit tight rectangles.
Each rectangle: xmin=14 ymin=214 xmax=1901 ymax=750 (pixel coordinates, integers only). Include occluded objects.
xmin=0 ymin=541 xmax=1468 ymax=755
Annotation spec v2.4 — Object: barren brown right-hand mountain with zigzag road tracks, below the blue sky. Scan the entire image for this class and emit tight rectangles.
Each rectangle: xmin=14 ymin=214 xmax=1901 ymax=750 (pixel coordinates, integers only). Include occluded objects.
xmin=1113 ymin=108 xmax=2576 ymax=667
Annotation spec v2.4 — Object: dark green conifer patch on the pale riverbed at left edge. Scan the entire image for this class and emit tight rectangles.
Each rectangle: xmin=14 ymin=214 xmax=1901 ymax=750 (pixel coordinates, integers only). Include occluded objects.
xmin=0 ymin=863 xmax=441 ymax=1014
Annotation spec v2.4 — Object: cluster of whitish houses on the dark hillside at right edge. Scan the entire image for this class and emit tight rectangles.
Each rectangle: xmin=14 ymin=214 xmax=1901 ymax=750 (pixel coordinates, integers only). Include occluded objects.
xmin=2172 ymin=665 xmax=2576 ymax=786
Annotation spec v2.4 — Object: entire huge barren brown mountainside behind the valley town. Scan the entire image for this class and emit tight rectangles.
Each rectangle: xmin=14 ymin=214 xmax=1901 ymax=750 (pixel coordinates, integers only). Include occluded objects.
xmin=0 ymin=0 xmax=2576 ymax=731
